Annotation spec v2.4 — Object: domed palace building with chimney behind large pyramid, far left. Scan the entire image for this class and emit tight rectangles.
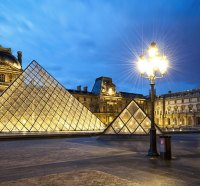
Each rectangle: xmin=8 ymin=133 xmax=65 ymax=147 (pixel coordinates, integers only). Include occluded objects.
xmin=0 ymin=45 xmax=22 ymax=93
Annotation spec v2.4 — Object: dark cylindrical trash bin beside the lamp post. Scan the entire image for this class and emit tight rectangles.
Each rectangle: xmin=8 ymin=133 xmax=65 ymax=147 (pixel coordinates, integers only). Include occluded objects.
xmin=160 ymin=136 xmax=171 ymax=160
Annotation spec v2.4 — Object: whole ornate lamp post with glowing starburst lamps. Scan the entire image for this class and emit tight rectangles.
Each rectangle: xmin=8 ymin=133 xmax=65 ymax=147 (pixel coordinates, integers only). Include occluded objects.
xmin=137 ymin=42 xmax=168 ymax=157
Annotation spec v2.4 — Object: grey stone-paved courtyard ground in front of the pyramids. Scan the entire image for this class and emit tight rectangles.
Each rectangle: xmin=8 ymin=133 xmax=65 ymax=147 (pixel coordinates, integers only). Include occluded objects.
xmin=0 ymin=134 xmax=200 ymax=186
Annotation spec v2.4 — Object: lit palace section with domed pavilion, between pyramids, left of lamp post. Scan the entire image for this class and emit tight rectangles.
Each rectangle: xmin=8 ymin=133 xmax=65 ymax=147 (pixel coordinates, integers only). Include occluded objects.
xmin=68 ymin=77 xmax=145 ymax=125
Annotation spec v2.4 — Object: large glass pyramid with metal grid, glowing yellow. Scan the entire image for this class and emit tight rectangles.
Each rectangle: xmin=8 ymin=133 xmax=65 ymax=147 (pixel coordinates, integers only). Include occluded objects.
xmin=0 ymin=61 xmax=105 ymax=132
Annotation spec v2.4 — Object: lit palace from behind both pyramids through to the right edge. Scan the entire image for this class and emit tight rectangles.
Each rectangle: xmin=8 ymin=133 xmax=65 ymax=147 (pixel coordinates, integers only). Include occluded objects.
xmin=69 ymin=77 xmax=200 ymax=128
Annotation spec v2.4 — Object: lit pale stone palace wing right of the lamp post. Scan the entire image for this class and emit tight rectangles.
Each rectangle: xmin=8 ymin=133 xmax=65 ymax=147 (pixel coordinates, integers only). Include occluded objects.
xmin=155 ymin=89 xmax=200 ymax=128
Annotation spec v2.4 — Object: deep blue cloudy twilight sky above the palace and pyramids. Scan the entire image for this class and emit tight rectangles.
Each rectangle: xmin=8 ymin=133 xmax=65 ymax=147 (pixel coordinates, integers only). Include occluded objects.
xmin=0 ymin=0 xmax=200 ymax=95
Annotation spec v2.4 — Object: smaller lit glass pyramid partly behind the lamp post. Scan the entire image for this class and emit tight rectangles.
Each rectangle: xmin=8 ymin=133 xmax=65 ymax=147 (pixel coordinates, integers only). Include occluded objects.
xmin=104 ymin=100 xmax=161 ymax=134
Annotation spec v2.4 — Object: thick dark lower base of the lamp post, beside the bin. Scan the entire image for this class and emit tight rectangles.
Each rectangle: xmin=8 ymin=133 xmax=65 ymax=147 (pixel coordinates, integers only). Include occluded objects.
xmin=148 ymin=128 xmax=159 ymax=157
